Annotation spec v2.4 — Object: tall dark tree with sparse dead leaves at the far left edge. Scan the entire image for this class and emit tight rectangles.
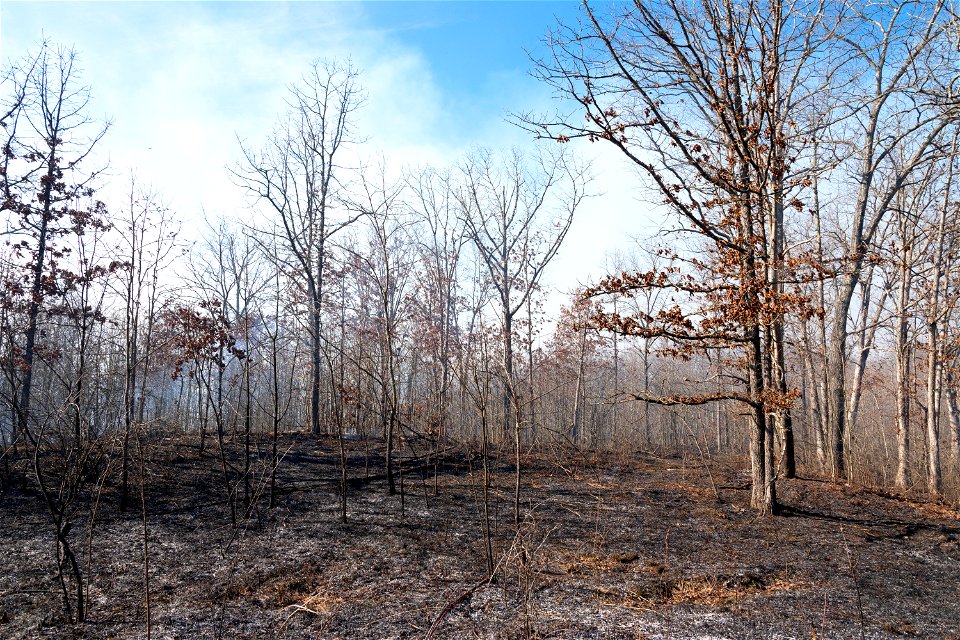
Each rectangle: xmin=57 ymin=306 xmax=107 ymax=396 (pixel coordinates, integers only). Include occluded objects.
xmin=2 ymin=43 xmax=107 ymax=440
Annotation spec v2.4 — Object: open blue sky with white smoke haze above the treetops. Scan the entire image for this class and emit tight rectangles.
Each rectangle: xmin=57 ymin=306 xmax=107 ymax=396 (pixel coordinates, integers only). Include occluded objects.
xmin=0 ymin=0 xmax=649 ymax=300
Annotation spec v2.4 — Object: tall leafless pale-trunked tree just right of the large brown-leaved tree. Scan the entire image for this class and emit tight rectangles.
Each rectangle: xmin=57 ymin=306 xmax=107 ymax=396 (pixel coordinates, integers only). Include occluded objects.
xmin=824 ymin=0 xmax=958 ymax=479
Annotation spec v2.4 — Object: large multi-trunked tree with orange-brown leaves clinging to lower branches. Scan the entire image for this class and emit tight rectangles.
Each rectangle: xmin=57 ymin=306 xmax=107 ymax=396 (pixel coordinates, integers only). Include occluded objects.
xmin=519 ymin=0 xmax=848 ymax=510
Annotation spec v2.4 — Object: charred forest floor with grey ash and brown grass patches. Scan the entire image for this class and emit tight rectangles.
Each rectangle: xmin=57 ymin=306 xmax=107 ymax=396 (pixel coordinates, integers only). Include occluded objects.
xmin=0 ymin=435 xmax=960 ymax=640
